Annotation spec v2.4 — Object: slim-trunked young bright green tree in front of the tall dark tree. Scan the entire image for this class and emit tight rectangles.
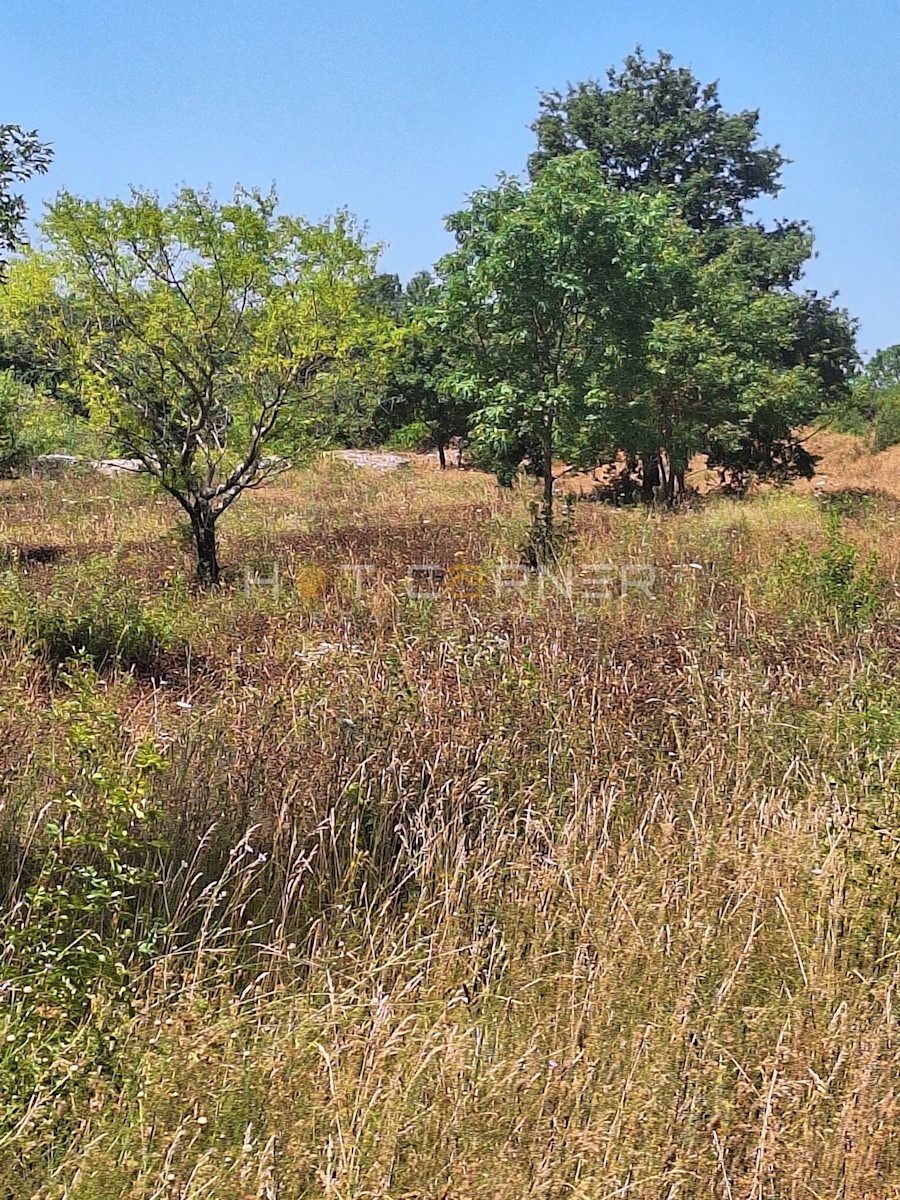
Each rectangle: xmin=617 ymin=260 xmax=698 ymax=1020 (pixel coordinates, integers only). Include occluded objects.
xmin=438 ymin=154 xmax=697 ymax=532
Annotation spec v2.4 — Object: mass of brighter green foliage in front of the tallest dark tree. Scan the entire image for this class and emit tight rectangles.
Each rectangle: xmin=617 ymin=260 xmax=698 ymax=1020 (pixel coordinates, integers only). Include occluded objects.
xmin=439 ymin=152 xmax=842 ymax=510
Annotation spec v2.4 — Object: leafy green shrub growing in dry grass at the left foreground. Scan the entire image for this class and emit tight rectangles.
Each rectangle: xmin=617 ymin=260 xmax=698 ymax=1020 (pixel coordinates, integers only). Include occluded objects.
xmin=0 ymin=662 xmax=167 ymax=1157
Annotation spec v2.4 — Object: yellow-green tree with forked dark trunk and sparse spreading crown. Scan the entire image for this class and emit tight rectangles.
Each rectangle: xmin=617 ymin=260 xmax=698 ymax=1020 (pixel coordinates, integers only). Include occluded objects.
xmin=0 ymin=188 xmax=379 ymax=584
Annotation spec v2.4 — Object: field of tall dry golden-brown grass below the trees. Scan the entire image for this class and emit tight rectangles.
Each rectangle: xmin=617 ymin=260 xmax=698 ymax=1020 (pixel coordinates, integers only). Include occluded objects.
xmin=0 ymin=444 xmax=900 ymax=1200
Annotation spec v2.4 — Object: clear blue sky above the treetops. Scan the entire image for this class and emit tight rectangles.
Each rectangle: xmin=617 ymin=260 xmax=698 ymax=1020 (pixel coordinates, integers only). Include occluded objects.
xmin=0 ymin=0 xmax=900 ymax=353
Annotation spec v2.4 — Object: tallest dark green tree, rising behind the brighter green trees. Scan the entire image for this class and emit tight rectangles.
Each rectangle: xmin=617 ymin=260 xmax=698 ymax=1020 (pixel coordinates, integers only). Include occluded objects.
xmin=529 ymin=48 xmax=858 ymax=494
